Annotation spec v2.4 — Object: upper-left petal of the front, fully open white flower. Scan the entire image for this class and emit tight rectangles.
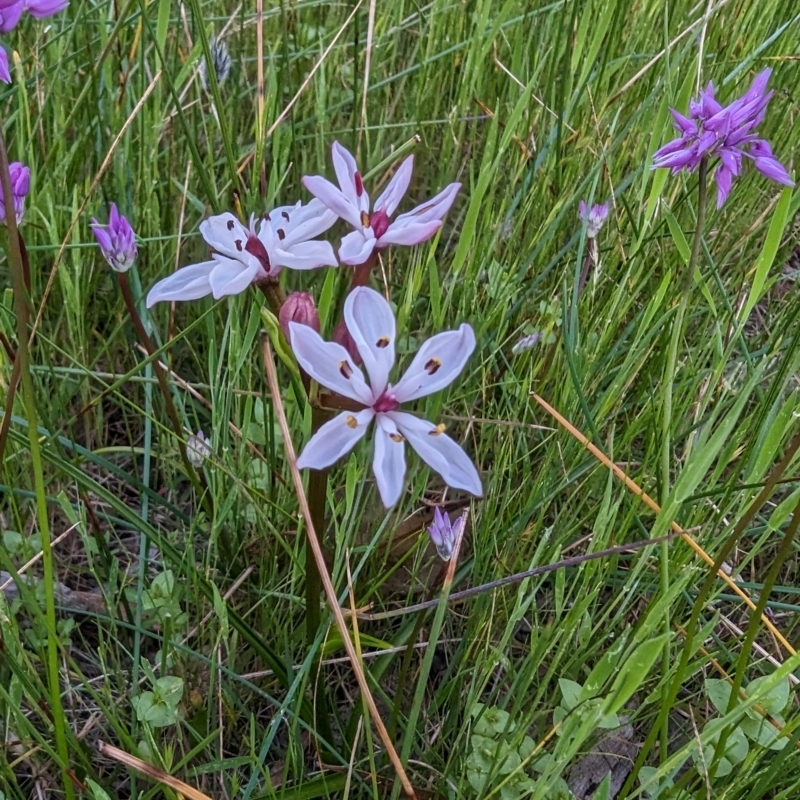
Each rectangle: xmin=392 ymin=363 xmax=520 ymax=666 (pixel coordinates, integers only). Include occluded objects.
xmin=289 ymin=322 xmax=374 ymax=406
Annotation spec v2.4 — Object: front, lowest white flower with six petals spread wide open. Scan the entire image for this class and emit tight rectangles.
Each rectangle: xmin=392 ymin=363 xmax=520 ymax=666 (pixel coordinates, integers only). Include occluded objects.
xmin=289 ymin=286 xmax=483 ymax=508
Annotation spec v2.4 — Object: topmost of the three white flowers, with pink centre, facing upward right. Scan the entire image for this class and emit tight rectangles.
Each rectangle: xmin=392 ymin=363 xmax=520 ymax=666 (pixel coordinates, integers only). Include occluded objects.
xmin=303 ymin=142 xmax=461 ymax=265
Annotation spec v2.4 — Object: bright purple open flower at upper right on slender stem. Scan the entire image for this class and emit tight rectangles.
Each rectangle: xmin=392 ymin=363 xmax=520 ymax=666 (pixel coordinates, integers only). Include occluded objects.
xmin=653 ymin=69 xmax=794 ymax=208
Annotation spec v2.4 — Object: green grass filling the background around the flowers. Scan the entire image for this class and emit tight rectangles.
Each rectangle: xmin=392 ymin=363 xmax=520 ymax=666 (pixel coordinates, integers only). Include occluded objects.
xmin=0 ymin=0 xmax=800 ymax=800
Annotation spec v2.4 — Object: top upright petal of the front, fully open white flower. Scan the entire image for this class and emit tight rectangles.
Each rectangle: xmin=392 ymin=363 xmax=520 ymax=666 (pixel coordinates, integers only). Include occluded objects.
xmin=344 ymin=286 xmax=396 ymax=398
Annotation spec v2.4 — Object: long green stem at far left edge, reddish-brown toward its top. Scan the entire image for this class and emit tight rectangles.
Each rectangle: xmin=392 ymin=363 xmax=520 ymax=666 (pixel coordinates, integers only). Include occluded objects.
xmin=0 ymin=131 xmax=75 ymax=800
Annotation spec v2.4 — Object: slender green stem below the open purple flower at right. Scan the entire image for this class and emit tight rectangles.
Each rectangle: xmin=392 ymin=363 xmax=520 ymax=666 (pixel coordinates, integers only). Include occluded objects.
xmin=659 ymin=158 xmax=708 ymax=761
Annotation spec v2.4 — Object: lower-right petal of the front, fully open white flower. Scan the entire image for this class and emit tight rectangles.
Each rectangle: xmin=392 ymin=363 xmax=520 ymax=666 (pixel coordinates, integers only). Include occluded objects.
xmin=386 ymin=411 xmax=483 ymax=497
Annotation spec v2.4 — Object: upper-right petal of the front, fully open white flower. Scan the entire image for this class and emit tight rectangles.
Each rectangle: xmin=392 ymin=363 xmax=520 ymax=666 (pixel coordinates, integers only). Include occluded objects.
xmin=392 ymin=322 xmax=475 ymax=403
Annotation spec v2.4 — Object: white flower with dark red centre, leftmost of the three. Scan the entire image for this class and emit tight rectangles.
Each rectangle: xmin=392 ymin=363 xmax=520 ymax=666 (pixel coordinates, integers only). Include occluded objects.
xmin=147 ymin=200 xmax=337 ymax=308
